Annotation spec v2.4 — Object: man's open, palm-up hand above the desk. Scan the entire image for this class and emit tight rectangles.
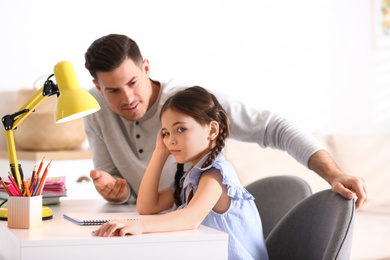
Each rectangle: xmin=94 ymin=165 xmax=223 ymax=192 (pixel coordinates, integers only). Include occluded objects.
xmin=90 ymin=170 xmax=130 ymax=202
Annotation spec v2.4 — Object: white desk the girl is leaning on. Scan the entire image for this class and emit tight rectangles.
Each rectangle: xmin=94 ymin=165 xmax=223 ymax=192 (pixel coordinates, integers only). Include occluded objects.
xmin=0 ymin=200 xmax=228 ymax=260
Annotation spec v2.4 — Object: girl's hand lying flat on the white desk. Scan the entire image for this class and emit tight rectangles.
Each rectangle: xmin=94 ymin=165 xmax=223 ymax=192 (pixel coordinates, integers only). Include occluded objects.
xmin=95 ymin=220 xmax=142 ymax=237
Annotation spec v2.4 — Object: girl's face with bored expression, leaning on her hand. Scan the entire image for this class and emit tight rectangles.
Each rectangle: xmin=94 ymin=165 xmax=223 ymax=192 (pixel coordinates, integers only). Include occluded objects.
xmin=161 ymin=109 xmax=218 ymax=165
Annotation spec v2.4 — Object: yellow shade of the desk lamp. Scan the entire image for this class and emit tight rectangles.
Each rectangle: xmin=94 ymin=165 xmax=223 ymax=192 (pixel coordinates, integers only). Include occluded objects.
xmin=54 ymin=61 xmax=100 ymax=123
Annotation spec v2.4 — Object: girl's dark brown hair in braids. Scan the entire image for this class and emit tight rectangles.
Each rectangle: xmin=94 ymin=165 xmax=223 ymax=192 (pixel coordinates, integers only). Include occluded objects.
xmin=160 ymin=86 xmax=230 ymax=206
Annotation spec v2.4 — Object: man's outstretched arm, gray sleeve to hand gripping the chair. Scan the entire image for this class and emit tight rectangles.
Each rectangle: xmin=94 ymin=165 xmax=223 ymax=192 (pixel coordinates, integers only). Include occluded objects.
xmin=218 ymin=92 xmax=367 ymax=209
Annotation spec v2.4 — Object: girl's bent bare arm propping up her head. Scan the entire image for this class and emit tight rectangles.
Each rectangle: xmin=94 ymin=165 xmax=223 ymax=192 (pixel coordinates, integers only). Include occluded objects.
xmin=137 ymin=131 xmax=174 ymax=214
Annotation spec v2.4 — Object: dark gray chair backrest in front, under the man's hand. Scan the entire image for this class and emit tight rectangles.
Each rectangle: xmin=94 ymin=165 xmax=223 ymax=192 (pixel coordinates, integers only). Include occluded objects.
xmin=266 ymin=190 xmax=355 ymax=260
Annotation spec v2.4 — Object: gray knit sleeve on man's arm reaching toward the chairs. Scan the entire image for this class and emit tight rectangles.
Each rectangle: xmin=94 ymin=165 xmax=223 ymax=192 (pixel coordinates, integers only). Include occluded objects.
xmin=218 ymin=94 xmax=324 ymax=167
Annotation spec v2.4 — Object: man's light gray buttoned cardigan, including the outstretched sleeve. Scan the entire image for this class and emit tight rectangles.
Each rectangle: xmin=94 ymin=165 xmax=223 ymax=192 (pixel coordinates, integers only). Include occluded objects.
xmin=84 ymin=77 xmax=323 ymax=201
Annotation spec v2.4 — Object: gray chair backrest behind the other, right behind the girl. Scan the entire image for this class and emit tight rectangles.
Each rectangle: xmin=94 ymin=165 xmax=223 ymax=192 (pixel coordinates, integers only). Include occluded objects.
xmin=246 ymin=175 xmax=312 ymax=238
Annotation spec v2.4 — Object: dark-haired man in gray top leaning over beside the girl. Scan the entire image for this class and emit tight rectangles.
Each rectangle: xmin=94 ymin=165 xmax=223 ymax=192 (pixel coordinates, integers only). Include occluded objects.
xmin=84 ymin=34 xmax=367 ymax=209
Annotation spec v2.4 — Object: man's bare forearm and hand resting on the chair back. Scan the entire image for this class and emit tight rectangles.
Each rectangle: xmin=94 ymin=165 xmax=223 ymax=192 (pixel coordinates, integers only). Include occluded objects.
xmin=309 ymin=150 xmax=367 ymax=209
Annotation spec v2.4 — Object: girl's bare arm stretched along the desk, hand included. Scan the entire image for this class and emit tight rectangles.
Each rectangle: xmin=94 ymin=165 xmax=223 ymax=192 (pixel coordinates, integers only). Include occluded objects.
xmin=95 ymin=168 xmax=230 ymax=236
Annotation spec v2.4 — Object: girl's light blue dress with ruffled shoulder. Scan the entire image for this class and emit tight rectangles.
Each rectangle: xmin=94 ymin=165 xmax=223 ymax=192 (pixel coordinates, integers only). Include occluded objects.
xmin=171 ymin=152 xmax=268 ymax=260
